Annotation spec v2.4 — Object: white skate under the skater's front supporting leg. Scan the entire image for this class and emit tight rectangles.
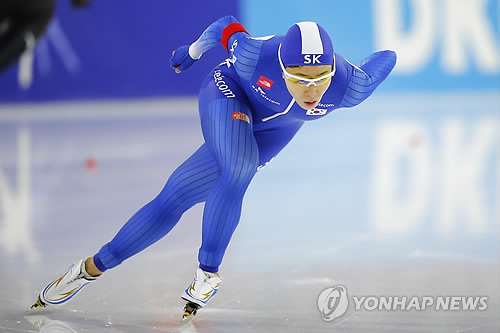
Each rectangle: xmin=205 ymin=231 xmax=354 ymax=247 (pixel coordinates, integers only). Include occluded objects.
xmin=181 ymin=268 xmax=222 ymax=321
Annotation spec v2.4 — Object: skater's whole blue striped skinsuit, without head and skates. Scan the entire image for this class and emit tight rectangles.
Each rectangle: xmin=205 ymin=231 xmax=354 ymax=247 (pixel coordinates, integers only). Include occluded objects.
xmin=94 ymin=16 xmax=396 ymax=272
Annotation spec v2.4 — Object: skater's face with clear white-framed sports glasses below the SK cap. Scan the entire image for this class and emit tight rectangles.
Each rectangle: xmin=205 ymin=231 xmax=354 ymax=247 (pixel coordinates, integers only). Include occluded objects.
xmin=283 ymin=65 xmax=332 ymax=110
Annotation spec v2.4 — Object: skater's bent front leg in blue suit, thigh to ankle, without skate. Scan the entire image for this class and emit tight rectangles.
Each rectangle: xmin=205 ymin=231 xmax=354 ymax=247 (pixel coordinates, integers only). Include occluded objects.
xmin=198 ymin=92 xmax=259 ymax=273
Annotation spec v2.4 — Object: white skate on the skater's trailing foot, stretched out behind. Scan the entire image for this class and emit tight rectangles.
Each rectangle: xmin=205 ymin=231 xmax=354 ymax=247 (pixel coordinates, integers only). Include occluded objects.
xmin=30 ymin=259 xmax=97 ymax=310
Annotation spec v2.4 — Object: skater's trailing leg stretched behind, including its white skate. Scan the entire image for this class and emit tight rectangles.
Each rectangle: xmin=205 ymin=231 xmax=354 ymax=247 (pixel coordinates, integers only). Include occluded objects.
xmin=32 ymin=145 xmax=218 ymax=309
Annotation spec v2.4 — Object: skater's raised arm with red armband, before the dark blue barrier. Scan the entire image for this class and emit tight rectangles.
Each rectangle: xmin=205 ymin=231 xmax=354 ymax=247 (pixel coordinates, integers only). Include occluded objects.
xmin=170 ymin=16 xmax=252 ymax=73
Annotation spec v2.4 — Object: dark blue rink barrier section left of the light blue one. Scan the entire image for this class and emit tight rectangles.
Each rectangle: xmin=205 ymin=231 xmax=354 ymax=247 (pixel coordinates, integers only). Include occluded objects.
xmin=0 ymin=0 xmax=239 ymax=103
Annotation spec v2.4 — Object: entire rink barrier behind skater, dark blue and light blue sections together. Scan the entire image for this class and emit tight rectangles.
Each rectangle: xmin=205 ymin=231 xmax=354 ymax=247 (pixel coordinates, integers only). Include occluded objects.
xmin=0 ymin=0 xmax=500 ymax=103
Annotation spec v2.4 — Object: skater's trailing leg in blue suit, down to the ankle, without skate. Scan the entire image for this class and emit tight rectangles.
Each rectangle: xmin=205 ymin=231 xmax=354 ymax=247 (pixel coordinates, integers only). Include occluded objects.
xmin=93 ymin=144 xmax=219 ymax=272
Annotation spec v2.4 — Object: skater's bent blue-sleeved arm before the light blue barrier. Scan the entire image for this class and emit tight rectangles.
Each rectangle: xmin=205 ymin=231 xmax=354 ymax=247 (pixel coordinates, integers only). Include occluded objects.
xmin=339 ymin=50 xmax=396 ymax=107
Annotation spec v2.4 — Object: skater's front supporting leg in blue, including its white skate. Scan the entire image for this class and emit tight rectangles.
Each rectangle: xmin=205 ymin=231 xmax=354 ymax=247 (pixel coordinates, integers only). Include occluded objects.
xmin=182 ymin=70 xmax=259 ymax=312
